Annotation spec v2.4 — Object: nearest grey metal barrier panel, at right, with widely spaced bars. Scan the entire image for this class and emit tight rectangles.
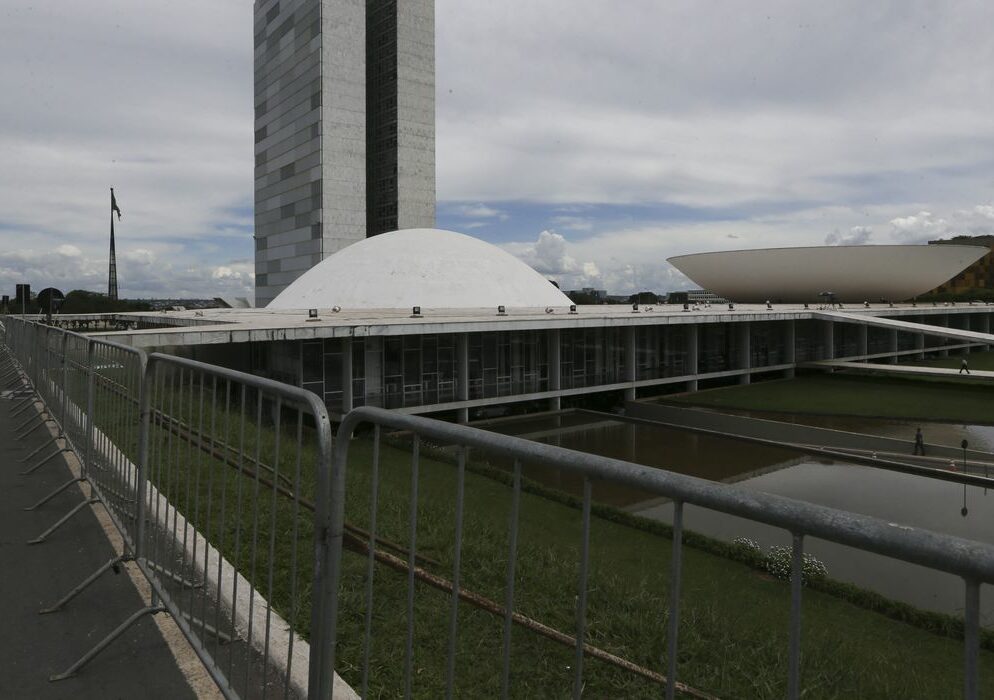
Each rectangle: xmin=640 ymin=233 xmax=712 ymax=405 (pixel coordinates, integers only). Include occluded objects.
xmin=326 ymin=407 xmax=994 ymax=698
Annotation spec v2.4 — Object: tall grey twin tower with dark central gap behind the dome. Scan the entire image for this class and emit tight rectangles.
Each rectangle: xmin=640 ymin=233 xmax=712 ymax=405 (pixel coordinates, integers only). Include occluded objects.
xmin=255 ymin=0 xmax=435 ymax=307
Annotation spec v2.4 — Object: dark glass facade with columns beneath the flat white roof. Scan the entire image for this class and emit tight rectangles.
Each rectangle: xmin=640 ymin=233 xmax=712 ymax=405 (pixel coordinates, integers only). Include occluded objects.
xmin=248 ymin=308 xmax=989 ymax=411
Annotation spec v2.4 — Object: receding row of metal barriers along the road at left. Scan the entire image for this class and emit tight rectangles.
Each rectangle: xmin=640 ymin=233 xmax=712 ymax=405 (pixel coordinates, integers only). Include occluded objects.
xmin=0 ymin=317 xmax=340 ymax=698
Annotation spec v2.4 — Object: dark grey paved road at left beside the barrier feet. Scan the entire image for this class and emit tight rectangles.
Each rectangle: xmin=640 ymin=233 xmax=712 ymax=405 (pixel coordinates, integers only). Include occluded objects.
xmin=0 ymin=398 xmax=195 ymax=700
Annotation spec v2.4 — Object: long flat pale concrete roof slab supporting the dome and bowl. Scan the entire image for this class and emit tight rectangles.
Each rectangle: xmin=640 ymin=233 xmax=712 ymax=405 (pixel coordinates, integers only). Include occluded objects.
xmin=44 ymin=303 xmax=994 ymax=347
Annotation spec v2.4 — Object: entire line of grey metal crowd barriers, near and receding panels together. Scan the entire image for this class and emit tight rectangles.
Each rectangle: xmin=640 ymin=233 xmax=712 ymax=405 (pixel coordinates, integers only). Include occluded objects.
xmin=7 ymin=318 xmax=994 ymax=698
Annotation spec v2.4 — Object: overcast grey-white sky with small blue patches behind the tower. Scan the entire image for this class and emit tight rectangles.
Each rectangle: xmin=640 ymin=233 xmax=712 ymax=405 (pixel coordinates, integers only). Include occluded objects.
xmin=0 ymin=0 xmax=994 ymax=297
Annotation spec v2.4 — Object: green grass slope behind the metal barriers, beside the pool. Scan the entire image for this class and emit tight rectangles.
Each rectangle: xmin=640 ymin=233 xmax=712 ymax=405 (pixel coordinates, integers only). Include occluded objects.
xmin=87 ymin=374 xmax=994 ymax=698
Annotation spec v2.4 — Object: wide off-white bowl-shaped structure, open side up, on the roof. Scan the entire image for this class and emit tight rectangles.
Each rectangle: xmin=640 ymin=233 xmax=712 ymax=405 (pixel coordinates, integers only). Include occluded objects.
xmin=667 ymin=245 xmax=990 ymax=303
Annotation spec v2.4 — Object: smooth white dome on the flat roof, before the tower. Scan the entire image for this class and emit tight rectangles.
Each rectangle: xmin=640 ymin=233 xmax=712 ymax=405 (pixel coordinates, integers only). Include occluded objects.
xmin=267 ymin=228 xmax=570 ymax=309
